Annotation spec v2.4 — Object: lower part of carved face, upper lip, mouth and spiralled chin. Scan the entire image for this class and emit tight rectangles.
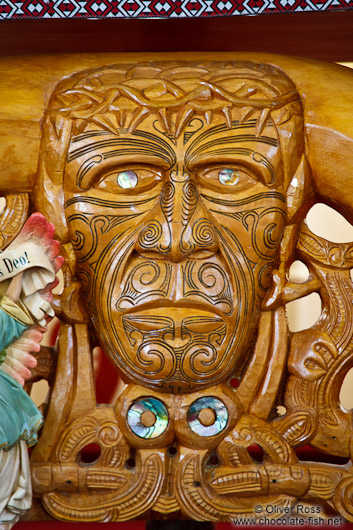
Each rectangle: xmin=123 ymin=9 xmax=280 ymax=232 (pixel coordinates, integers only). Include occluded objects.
xmin=93 ymin=245 xmax=258 ymax=393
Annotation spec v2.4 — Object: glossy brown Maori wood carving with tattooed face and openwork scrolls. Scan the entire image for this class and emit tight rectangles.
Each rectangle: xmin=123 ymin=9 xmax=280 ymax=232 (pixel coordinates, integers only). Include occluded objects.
xmin=0 ymin=54 xmax=353 ymax=522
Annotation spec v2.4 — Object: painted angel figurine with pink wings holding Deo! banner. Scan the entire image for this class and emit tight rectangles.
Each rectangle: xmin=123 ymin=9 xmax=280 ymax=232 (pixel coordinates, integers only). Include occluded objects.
xmin=0 ymin=213 xmax=62 ymax=530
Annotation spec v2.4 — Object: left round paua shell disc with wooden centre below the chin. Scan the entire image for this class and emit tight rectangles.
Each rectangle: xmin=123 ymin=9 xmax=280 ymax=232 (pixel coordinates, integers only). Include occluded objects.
xmin=127 ymin=398 xmax=169 ymax=438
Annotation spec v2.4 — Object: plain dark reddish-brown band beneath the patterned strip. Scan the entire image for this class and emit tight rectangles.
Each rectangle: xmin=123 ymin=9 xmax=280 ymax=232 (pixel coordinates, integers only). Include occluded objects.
xmin=0 ymin=10 xmax=353 ymax=61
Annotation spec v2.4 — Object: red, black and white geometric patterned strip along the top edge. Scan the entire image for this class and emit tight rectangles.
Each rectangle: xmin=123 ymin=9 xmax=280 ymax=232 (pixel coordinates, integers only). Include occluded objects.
xmin=0 ymin=0 xmax=353 ymax=20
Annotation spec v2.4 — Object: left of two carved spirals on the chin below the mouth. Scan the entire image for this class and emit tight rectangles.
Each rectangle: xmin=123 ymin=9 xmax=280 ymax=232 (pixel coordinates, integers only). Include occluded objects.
xmin=135 ymin=341 xmax=176 ymax=381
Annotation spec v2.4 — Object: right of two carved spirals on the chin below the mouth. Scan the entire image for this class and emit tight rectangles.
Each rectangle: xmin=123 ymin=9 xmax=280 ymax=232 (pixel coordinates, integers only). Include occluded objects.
xmin=180 ymin=342 xmax=219 ymax=381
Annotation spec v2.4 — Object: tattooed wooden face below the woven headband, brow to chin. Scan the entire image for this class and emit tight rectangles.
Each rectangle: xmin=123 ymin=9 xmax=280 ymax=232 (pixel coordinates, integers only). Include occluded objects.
xmin=64 ymin=114 xmax=286 ymax=392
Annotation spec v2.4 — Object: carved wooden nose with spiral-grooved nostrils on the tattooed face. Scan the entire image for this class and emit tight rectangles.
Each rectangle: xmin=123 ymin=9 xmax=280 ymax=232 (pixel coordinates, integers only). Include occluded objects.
xmin=136 ymin=177 xmax=218 ymax=262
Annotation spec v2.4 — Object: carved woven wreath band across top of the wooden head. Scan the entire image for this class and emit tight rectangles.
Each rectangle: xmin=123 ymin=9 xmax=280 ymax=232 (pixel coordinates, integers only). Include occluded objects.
xmin=48 ymin=61 xmax=301 ymax=136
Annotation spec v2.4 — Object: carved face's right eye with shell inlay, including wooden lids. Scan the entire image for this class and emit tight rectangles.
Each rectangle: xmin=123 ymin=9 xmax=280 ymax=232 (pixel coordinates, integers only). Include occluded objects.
xmin=199 ymin=166 xmax=258 ymax=193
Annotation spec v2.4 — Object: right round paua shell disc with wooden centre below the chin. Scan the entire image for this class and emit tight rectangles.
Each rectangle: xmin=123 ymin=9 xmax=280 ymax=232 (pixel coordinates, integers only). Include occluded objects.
xmin=188 ymin=396 xmax=228 ymax=436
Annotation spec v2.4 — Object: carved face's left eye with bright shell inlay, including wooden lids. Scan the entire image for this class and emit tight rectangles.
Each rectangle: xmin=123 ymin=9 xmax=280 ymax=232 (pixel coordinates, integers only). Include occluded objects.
xmin=96 ymin=167 xmax=162 ymax=194
